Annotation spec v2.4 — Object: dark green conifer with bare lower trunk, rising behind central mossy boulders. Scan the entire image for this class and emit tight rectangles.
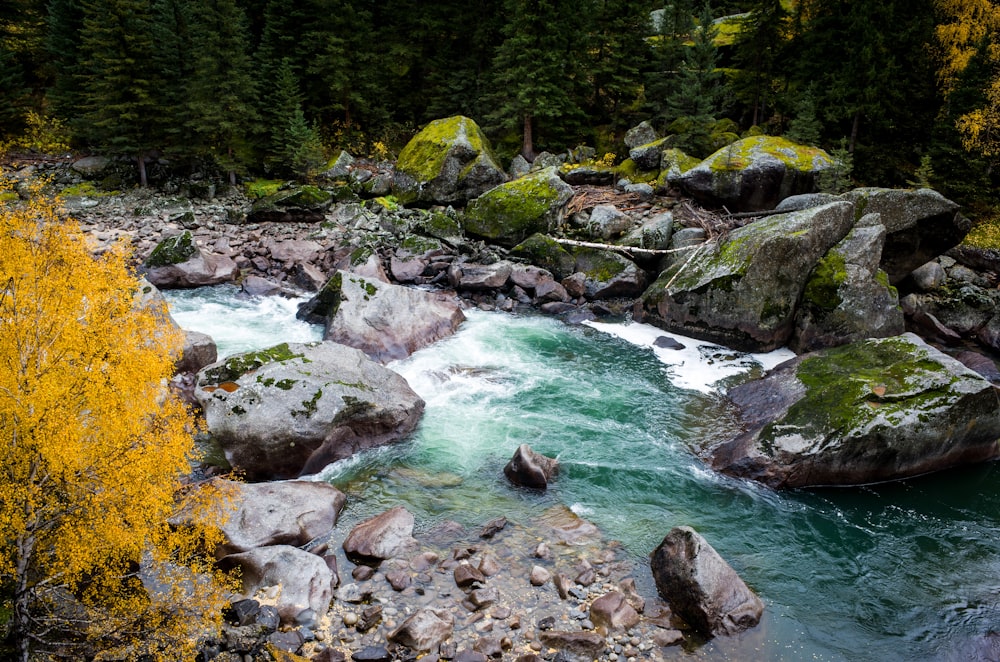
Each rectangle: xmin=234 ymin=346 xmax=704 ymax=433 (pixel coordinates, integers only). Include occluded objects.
xmin=489 ymin=0 xmax=586 ymax=160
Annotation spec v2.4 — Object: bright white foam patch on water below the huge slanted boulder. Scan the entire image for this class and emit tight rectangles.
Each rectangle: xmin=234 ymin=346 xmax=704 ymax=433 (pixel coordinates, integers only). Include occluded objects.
xmin=584 ymin=321 xmax=795 ymax=393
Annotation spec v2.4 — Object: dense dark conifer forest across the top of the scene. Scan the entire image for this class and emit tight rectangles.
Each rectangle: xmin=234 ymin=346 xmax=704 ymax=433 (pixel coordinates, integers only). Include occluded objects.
xmin=0 ymin=0 xmax=1000 ymax=216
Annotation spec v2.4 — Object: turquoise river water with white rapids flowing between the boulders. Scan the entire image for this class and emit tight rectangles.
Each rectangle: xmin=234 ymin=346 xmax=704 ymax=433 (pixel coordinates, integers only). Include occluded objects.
xmin=166 ymin=288 xmax=1000 ymax=660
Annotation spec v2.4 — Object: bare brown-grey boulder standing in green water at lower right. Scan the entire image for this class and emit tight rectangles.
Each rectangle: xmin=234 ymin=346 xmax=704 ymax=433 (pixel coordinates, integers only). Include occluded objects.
xmin=650 ymin=526 xmax=764 ymax=637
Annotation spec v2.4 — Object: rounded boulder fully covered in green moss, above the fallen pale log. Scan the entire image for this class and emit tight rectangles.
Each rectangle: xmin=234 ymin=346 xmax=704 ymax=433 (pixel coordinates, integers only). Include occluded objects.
xmin=464 ymin=167 xmax=573 ymax=246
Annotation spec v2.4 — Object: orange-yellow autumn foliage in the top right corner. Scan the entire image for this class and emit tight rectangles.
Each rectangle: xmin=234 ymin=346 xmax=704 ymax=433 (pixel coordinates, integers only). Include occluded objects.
xmin=936 ymin=0 xmax=1000 ymax=157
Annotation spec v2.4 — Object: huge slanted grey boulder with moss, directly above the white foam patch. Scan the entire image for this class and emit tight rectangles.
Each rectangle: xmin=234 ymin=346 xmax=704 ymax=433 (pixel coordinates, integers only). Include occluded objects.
xmin=639 ymin=202 xmax=854 ymax=351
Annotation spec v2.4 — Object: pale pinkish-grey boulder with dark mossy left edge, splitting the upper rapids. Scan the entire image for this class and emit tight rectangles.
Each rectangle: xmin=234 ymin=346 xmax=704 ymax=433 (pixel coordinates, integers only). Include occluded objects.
xmin=298 ymin=271 xmax=465 ymax=363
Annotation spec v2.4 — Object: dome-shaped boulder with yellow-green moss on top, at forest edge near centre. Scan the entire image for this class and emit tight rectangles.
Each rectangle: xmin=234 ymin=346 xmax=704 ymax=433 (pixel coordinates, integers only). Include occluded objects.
xmin=392 ymin=115 xmax=507 ymax=205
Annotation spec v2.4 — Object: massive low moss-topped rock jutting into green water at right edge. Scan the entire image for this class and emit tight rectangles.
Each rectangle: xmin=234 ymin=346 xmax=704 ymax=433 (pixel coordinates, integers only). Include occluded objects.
xmin=708 ymin=333 xmax=1000 ymax=487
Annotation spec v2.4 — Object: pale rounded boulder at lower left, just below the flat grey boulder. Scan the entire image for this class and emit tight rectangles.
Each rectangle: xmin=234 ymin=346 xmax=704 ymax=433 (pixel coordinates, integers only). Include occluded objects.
xmin=221 ymin=545 xmax=333 ymax=624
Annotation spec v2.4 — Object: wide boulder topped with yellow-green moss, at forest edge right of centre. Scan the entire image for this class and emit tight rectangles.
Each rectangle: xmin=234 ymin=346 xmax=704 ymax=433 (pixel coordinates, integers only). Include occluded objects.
xmin=668 ymin=136 xmax=833 ymax=212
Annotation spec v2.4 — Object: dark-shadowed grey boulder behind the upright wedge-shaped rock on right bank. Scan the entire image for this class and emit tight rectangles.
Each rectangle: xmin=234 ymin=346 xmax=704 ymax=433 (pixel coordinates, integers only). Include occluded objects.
xmin=841 ymin=188 xmax=972 ymax=283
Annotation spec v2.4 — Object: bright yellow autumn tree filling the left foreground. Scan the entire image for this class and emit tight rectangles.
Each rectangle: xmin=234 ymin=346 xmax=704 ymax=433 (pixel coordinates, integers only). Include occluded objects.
xmin=0 ymin=179 xmax=234 ymax=662
